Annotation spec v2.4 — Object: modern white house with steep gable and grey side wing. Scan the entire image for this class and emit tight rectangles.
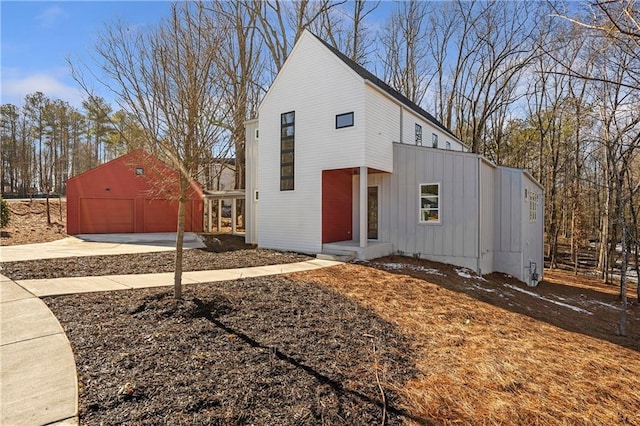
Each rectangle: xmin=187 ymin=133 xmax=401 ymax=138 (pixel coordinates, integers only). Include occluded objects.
xmin=246 ymin=32 xmax=543 ymax=282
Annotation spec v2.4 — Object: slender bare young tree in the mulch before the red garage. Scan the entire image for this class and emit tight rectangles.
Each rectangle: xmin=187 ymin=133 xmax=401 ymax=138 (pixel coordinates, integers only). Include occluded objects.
xmin=75 ymin=3 xmax=228 ymax=299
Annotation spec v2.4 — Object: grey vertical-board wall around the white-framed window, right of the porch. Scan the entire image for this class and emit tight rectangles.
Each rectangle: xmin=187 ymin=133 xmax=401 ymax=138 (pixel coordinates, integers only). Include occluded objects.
xmin=389 ymin=143 xmax=479 ymax=270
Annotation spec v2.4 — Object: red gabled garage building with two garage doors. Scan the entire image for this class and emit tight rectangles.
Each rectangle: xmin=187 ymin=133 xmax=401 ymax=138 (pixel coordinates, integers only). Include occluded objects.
xmin=67 ymin=150 xmax=203 ymax=235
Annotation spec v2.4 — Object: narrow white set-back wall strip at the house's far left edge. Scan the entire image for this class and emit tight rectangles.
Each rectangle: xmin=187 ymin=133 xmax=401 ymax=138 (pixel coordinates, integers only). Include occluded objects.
xmin=244 ymin=120 xmax=259 ymax=244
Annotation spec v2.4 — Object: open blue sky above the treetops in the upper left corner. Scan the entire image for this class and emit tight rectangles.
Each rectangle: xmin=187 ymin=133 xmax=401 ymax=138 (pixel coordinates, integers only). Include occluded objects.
xmin=0 ymin=0 xmax=175 ymax=108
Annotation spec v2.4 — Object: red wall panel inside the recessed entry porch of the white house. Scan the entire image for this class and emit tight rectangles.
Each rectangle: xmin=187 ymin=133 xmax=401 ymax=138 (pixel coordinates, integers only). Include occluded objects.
xmin=322 ymin=169 xmax=353 ymax=243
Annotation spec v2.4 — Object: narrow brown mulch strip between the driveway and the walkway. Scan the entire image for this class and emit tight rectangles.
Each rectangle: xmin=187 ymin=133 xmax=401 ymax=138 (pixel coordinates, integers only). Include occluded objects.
xmin=2 ymin=249 xmax=311 ymax=280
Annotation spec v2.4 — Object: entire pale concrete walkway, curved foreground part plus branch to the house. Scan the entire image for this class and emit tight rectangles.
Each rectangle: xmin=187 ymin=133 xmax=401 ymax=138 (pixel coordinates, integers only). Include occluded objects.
xmin=0 ymin=258 xmax=341 ymax=425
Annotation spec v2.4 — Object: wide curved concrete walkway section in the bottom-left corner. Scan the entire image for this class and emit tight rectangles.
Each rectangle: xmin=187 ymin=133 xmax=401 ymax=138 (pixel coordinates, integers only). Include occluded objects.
xmin=0 ymin=275 xmax=78 ymax=425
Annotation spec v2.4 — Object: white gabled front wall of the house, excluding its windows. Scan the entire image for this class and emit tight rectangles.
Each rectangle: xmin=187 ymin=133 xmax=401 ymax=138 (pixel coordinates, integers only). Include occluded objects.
xmin=258 ymin=32 xmax=366 ymax=253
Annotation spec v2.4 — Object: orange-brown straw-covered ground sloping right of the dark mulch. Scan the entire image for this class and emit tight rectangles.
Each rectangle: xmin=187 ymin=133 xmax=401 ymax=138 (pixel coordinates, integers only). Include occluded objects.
xmin=296 ymin=265 xmax=640 ymax=425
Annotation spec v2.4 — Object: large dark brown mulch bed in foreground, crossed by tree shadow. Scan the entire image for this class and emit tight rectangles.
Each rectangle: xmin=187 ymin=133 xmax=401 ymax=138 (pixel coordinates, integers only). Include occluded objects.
xmin=45 ymin=276 xmax=419 ymax=425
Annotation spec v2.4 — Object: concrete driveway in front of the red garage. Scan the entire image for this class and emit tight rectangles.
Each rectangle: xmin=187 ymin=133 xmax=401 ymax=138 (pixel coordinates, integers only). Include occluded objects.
xmin=0 ymin=232 xmax=204 ymax=262
